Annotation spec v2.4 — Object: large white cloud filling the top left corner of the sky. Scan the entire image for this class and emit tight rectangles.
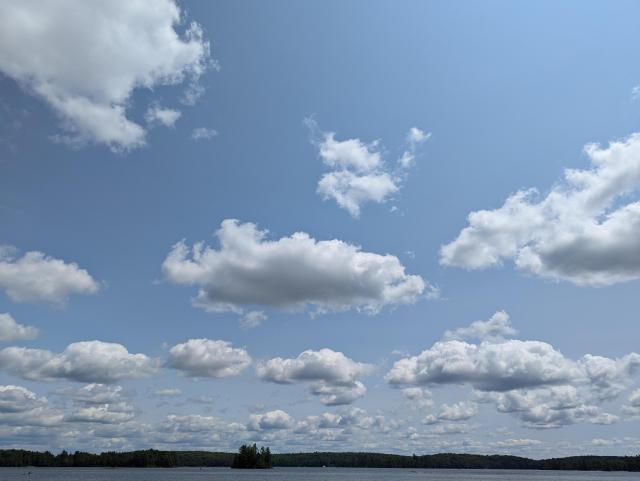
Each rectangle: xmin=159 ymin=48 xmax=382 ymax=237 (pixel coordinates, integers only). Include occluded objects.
xmin=0 ymin=0 xmax=209 ymax=150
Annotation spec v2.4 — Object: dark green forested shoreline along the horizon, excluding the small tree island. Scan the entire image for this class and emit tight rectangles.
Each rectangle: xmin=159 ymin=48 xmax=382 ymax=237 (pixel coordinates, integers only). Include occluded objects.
xmin=0 ymin=449 xmax=640 ymax=471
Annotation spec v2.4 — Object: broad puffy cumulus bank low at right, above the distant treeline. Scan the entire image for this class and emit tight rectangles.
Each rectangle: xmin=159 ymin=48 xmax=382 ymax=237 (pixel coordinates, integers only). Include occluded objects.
xmin=385 ymin=311 xmax=640 ymax=428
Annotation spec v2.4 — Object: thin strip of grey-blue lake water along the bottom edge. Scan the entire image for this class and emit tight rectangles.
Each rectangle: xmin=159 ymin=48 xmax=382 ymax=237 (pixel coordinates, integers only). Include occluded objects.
xmin=0 ymin=468 xmax=640 ymax=481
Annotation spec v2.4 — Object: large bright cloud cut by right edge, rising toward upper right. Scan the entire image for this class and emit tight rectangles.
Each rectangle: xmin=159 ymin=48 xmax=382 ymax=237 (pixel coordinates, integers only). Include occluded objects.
xmin=440 ymin=133 xmax=640 ymax=286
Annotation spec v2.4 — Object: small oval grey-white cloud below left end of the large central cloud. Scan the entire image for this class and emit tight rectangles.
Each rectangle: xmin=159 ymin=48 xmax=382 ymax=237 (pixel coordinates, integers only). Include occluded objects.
xmin=167 ymin=339 xmax=251 ymax=378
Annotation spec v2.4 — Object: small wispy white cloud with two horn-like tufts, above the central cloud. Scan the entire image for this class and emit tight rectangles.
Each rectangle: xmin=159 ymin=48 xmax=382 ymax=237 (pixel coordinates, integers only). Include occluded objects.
xmin=305 ymin=118 xmax=429 ymax=218
